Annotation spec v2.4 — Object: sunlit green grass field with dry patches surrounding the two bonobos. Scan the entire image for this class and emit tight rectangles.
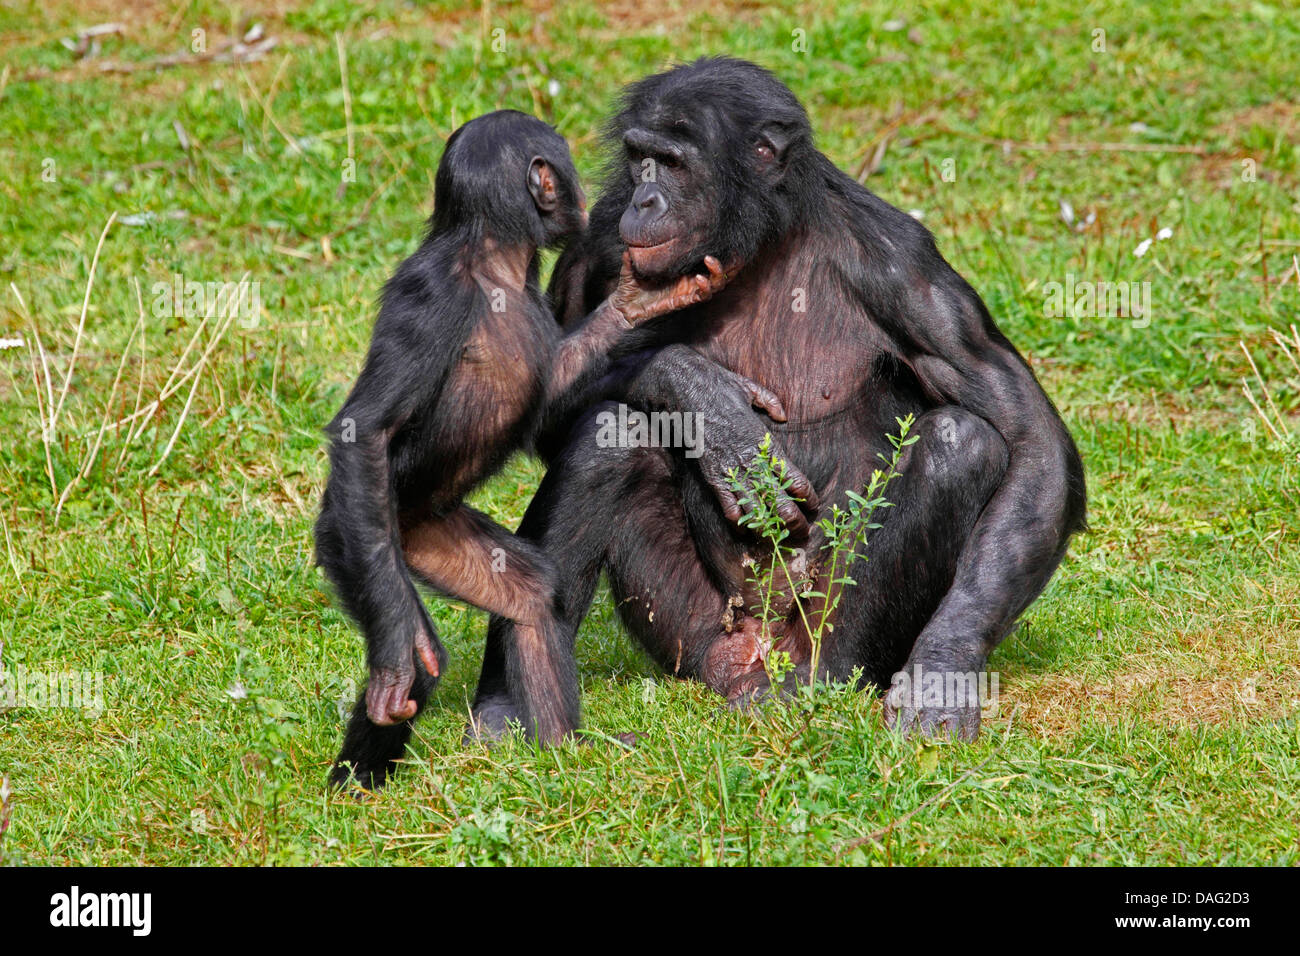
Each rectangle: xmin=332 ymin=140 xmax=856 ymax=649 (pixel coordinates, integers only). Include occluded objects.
xmin=0 ymin=0 xmax=1300 ymax=865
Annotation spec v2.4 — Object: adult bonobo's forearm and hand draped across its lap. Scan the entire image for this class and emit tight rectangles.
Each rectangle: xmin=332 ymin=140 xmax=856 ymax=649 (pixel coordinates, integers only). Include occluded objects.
xmin=628 ymin=345 xmax=818 ymax=537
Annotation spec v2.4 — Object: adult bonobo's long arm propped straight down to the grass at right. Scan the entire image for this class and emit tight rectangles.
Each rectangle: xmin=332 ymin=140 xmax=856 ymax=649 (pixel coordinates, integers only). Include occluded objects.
xmin=844 ymin=226 xmax=1086 ymax=734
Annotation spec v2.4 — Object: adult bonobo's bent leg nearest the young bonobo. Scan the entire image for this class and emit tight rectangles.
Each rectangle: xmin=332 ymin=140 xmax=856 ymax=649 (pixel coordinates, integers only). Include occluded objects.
xmin=471 ymin=403 xmax=800 ymax=737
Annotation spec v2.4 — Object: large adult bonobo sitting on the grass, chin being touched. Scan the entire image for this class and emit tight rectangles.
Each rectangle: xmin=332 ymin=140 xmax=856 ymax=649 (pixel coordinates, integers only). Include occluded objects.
xmin=475 ymin=59 xmax=1084 ymax=737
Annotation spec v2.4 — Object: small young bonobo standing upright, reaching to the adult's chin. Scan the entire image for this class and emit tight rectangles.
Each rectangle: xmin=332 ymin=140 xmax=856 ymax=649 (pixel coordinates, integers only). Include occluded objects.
xmin=316 ymin=111 xmax=727 ymax=788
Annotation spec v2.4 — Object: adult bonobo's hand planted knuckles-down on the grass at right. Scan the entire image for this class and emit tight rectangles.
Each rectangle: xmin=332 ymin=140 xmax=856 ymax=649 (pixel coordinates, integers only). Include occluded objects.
xmin=884 ymin=661 xmax=984 ymax=740
